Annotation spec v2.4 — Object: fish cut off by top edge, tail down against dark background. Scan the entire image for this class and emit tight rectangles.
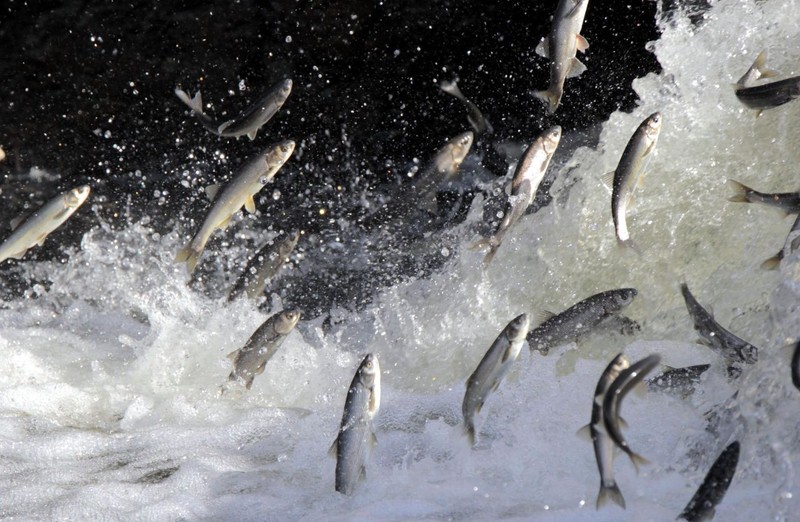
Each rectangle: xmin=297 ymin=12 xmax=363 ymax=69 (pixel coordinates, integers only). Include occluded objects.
xmin=534 ymin=0 xmax=589 ymax=114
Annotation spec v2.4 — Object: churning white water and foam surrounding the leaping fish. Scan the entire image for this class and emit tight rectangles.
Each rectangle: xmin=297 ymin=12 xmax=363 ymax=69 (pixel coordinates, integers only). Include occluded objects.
xmin=0 ymin=0 xmax=800 ymax=521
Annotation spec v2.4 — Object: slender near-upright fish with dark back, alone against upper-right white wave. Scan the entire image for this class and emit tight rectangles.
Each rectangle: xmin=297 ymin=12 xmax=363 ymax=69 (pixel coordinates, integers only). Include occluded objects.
xmin=604 ymin=112 xmax=662 ymax=253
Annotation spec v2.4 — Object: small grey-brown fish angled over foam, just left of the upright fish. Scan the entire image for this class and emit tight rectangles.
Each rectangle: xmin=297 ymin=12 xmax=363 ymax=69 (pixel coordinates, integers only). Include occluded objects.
xmin=228 ymin=310 xmax=300 ymax=390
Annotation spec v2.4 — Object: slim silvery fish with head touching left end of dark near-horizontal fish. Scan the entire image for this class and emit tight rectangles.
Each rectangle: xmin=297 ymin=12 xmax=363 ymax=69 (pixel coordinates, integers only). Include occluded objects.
xmin=461 ymin=314 xmax=530 ymax=446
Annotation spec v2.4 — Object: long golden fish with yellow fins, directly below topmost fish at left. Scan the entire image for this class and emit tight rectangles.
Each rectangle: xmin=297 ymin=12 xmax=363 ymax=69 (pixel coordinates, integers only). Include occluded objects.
xmin=175 ymin=140 xmax=294 ymax=273
